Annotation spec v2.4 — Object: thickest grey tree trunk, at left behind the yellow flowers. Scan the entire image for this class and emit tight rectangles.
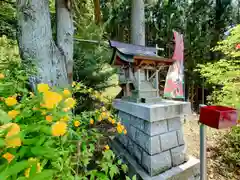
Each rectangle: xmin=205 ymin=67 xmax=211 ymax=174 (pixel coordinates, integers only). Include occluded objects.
xmin=16 ymin=0 xmax=72 ymax=89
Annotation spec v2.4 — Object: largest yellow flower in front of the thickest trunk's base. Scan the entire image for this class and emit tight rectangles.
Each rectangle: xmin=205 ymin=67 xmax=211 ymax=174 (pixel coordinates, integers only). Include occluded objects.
xmin=42 ymin=91 xmax=62 ymax=109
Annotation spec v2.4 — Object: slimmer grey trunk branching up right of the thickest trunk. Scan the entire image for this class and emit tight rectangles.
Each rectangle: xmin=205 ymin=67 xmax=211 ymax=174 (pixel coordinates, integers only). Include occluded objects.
xmin=56 ymin=0 xmax=74 ymax=83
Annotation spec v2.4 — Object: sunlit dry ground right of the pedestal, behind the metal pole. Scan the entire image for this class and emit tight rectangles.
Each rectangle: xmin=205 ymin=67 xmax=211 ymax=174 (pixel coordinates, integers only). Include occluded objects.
xmin=183 ymin=115 xmax=240 ymax=180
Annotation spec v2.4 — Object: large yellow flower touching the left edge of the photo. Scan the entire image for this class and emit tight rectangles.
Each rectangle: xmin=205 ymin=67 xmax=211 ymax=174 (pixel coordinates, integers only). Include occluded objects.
xmin=0 ymin=123 xmax=22 ymax=148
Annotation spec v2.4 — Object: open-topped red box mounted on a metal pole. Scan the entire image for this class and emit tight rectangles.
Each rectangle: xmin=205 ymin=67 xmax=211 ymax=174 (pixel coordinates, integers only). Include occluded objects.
xmin=199 ymin=106 xmax=238 ymax=129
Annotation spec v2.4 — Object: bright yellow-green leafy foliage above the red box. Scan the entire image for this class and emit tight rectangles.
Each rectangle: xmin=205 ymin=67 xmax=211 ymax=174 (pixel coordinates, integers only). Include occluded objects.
xmin=199 ymin=26 xmax=240 ymax=108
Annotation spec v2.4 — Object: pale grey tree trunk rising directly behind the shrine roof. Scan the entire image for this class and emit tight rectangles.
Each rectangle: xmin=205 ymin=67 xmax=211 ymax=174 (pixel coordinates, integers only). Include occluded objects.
xmin=131 ymin=0 xmax=145 ymax=46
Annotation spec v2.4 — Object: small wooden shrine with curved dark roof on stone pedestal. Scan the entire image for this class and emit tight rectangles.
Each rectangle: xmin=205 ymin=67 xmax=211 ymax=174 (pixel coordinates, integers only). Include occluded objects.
xmin=109 ymin=41 xmax=175 ymax=103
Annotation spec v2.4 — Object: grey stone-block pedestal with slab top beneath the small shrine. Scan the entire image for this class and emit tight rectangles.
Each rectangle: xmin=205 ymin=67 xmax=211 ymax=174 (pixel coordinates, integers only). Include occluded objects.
xmin=114 ymin=99 xmax=198 ymax=179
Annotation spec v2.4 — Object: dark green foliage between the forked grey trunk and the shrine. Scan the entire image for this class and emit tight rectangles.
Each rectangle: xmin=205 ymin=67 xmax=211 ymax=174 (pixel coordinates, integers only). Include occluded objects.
xmin=73 ymin=0 xmax=116 ymax=112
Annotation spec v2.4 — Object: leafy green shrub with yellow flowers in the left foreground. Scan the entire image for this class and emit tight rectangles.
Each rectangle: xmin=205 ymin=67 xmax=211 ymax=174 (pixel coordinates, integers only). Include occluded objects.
xmin=0 ymin=69 xmax=133 ymax=180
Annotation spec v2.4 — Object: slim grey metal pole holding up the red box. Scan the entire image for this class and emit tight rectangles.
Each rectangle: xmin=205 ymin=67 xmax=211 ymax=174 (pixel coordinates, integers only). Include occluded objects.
xmin=199 ymin=104 xmax=207 ymax=180
